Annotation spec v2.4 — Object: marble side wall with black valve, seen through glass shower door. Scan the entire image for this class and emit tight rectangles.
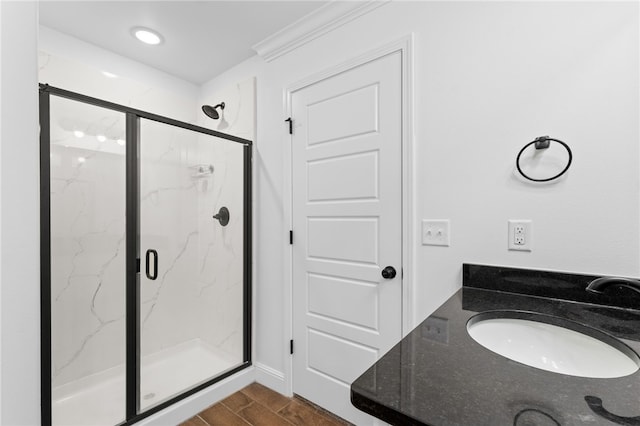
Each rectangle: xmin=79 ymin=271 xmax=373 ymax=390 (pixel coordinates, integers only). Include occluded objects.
xmin=191 ymin=136 xmax=244 ymax=361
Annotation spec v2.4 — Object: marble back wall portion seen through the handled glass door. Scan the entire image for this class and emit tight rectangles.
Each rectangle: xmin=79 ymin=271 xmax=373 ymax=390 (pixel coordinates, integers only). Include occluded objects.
xmin=140 ymin=119 xmax=199 ymax=356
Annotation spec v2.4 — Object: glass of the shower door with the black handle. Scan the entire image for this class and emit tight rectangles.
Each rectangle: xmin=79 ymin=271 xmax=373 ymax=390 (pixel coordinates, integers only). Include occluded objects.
xmin=139 ymin=119 xmax=244 ymax=411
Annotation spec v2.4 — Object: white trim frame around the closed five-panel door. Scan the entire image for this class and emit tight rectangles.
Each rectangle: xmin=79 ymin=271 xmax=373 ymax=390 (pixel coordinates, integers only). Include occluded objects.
xmin=282 ymin=34 xmax=415 ymax=395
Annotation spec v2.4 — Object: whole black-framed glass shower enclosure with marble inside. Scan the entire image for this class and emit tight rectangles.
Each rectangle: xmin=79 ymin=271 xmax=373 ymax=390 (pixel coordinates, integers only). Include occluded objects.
xmin=40 ymin=85 xmax=251 ymax=426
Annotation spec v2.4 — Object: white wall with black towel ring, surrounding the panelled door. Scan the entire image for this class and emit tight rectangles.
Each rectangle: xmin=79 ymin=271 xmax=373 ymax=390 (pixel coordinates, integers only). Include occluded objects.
xmin=202 ymin=2 xmax=640 ymax=382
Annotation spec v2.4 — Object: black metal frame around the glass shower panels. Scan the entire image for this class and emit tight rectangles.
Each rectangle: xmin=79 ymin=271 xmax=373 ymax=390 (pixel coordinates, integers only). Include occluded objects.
xmin=39 ymin=84 xmax=252 ymax=426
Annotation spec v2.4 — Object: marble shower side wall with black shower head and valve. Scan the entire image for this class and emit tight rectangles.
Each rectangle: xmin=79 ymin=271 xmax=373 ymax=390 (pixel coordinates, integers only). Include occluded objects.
xmin=198 ymin=77 xmax=256 ymax=359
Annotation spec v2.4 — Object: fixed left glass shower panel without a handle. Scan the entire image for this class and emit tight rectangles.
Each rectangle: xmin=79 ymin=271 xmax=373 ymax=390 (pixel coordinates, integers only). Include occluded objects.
xmin=49 ymin=97 xmax=125 ymax=425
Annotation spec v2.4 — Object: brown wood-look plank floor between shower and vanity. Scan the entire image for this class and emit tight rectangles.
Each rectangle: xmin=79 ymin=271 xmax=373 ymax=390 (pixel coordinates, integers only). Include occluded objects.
xmin=181 ymin=383 xmax=350 ymax=426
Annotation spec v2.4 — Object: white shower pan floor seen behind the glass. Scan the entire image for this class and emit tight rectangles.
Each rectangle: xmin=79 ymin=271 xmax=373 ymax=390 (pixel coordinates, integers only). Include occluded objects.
xmin=52 ymin=339 xmax=241 ymax=426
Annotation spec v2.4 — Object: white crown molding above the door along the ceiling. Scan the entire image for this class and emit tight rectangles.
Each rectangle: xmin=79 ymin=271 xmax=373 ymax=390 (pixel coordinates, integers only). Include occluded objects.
xmin=252 ymin=0 xmax=391 ymax=62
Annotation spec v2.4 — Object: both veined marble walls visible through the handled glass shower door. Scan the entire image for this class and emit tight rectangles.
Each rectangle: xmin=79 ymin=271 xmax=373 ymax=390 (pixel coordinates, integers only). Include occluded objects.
xmin=140 ymin=121 xmax=243 ymax=359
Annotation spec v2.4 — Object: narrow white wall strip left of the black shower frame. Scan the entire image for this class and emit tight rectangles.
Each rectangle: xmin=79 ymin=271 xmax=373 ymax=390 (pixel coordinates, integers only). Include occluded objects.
xmin=0 ymin=2 xmax=40 ymax=425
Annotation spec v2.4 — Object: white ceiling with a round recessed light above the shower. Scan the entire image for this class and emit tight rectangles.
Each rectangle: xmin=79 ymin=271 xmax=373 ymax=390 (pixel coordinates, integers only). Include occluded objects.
xmin=40 ymin=0 xmax=328 ymax=85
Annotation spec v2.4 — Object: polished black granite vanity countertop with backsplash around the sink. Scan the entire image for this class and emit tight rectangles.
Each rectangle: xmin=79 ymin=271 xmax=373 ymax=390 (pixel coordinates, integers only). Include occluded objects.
xmin=351 ymin=264 xmax=640 ymax=426
